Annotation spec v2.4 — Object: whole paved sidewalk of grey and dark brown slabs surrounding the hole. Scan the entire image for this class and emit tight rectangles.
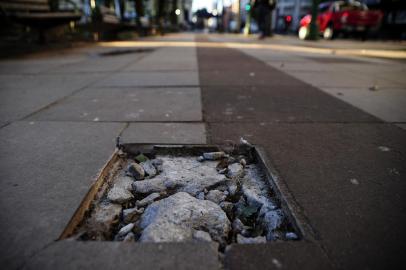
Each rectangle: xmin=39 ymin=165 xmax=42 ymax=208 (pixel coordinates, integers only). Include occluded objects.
xmin=0 ymin=33 xmax=406 ymax=270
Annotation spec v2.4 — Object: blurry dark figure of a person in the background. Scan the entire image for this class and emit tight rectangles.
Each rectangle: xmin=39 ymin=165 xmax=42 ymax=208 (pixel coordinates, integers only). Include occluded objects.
xmin=254 ymin=0 xmax=275 ymax=39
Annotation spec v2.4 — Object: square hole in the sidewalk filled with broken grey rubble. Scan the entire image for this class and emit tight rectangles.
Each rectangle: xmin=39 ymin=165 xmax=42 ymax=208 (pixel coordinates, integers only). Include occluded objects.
xmin=60 ymin=144 xmax=301 ymax=251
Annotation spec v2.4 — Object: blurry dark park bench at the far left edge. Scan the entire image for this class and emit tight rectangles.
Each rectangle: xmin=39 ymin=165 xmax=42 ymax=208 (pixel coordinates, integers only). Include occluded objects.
xmin=0 ymin=0 xmax=81 ymax=41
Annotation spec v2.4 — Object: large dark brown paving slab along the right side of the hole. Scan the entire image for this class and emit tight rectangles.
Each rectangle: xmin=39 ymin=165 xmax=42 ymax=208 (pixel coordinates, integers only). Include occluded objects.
xmin=209 ymin=124 xmax=406 ymax=269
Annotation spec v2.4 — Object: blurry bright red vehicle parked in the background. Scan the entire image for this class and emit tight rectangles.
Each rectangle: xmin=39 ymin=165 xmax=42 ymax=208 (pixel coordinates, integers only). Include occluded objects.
xmin=299 ymin=1 xmax=383 ymax=39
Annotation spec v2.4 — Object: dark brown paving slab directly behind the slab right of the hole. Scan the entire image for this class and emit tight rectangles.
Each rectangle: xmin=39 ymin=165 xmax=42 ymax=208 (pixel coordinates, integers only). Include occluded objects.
xmin=202 ymin=85 xmax=380 ymax=123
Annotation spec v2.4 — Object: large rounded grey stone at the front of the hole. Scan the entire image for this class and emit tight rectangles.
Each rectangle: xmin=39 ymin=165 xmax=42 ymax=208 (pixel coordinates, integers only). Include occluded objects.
xmin=140 ymin=192 xmax=231 ymax=242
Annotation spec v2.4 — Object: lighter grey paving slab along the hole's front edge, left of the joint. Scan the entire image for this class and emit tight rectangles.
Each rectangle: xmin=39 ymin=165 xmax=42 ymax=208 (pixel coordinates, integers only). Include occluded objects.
xmin=22 ymin=241 xmax=221 ymax=270
